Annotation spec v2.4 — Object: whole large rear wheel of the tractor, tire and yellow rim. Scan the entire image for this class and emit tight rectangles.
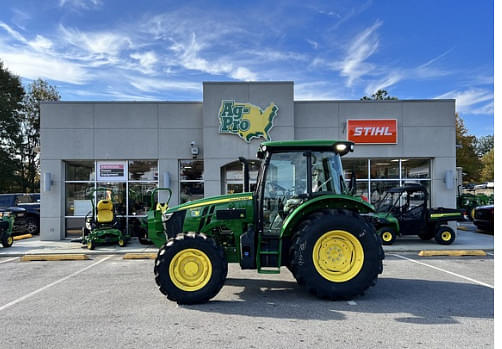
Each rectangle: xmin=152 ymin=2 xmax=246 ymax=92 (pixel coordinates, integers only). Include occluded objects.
xmin=290 ymin=209 xmax=384 ymax=300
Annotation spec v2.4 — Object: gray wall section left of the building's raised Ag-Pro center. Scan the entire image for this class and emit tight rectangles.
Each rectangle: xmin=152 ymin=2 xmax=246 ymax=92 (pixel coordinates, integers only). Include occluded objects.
xmin=40 ymin=102 xmax=202 ymax=240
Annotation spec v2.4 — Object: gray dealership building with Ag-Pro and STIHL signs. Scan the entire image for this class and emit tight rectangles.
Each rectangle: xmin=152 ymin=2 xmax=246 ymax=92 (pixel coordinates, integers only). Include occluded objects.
xmin=40 ymin=81 xmax=456 ymax=240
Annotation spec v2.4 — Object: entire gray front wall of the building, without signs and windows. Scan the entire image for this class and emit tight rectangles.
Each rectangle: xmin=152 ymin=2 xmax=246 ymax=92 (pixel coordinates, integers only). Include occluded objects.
xmin=40 ymin=81 xmax=456 ymax=240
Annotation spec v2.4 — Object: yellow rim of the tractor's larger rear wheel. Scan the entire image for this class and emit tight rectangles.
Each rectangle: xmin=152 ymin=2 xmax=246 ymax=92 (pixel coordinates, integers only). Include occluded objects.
xmin=312 ymin=230 xmax=364 ymax=282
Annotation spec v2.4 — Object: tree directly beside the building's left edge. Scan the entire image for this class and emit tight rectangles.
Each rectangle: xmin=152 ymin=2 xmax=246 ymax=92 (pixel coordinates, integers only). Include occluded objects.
xmin=18 ymin=79 xmax=61 ymax=193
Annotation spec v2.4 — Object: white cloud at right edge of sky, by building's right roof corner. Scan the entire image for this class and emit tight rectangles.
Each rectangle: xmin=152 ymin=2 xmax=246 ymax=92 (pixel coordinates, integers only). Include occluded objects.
xmin=434 ymin=88 xmax=493 ymax=114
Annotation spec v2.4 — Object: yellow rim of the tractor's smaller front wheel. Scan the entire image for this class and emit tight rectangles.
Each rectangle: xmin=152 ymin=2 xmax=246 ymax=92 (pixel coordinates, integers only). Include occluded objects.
xmin=169 ymin=248 xmax=213 ymax=292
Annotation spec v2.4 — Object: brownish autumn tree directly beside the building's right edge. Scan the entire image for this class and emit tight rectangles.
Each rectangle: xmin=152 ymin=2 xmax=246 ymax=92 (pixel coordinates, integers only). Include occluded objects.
xmin=455 ymin=114 xmax=481 ymax=182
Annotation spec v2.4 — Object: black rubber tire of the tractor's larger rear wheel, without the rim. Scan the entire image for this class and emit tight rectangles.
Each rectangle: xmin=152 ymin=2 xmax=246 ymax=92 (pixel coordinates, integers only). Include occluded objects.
xmin=290 ymin=209 xmax=385 ymax=300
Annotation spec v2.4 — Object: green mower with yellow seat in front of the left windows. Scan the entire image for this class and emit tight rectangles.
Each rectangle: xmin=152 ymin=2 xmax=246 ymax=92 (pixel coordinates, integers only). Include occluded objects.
xmin=82 ymin=188 xmax=129 ymax=250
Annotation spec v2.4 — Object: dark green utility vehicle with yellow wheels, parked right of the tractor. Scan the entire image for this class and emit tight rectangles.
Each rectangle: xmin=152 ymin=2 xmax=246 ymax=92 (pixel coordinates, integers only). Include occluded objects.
xmin=372 ymin=183 xmax=463 ymax=245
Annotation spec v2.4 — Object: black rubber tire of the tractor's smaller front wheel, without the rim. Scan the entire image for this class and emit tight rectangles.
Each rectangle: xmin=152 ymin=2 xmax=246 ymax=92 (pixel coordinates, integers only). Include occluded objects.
xmin=154 ymin=233 xmax=228 ymax=304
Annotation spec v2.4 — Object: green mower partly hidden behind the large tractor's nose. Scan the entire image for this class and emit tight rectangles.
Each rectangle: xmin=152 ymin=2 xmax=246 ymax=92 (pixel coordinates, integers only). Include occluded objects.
xmin=129 ymin=188 xmax=172 ymax=245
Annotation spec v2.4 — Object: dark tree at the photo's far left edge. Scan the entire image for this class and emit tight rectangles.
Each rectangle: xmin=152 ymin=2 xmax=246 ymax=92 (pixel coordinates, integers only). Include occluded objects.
xmin=0 ymin=61 xmax=24 ymax=192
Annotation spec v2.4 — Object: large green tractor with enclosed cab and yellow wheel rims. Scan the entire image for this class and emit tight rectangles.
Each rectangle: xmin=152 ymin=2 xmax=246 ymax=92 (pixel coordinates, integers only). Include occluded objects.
xmin=149 ymin=140 xmax=384 ymax=304
